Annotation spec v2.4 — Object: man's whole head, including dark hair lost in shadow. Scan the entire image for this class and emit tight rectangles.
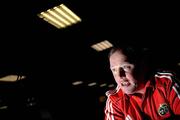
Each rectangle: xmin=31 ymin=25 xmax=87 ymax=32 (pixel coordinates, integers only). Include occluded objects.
xmin=109 ymin=46 xmax=152 ymax=94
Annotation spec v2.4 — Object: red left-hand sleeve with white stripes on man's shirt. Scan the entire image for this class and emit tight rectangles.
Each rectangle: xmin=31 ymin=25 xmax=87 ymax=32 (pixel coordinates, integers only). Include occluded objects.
xmin=104 ymin=97 xmax=124 ymax=120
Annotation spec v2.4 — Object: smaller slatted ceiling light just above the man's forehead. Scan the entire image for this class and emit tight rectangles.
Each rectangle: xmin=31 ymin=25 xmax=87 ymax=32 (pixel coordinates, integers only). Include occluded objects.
xmin=91 ymin=40 xmax=113 ymax=52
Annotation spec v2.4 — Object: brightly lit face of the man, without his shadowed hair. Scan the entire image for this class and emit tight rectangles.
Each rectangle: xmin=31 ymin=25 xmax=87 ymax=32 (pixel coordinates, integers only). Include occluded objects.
xmin=109 ymin=51 xmax=137 ymax=94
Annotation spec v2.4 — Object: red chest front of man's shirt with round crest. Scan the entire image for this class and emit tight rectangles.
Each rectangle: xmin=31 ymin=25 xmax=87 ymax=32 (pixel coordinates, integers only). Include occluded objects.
xmin=120 ymin=90 xmax=171 ymax=120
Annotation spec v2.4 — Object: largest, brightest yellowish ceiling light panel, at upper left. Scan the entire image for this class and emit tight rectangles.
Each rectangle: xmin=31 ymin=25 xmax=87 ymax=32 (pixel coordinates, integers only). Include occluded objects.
xmin=38 ymin=4 xmax=82 ymax=29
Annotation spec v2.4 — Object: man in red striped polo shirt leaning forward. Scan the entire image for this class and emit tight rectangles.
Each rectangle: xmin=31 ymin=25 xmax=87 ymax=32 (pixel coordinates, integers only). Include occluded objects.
xmin=105 ymin=46 xmax=180 ymax=120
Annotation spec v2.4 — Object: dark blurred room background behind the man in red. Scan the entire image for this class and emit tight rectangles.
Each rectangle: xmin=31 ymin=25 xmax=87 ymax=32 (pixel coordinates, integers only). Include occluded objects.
xmin=0 ymin=0 xmax=180 ymax=120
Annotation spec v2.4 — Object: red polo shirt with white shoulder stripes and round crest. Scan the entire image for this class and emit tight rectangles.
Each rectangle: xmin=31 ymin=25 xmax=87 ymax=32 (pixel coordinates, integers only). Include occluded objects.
xmin=105 ymin=73 xmax=180 ymax=120
